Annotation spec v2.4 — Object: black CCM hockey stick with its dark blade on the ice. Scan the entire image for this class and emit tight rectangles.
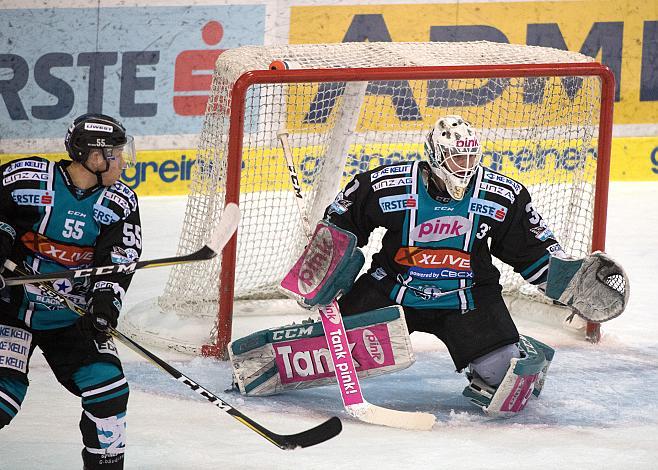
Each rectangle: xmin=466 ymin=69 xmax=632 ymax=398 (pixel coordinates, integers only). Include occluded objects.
xmin=5 ymin=258 xmax=342 ymax=450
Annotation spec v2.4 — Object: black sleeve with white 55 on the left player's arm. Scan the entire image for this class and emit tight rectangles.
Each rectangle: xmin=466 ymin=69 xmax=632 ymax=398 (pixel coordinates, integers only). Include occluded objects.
xmin=91 ymin=190 xmax=142 ymax=318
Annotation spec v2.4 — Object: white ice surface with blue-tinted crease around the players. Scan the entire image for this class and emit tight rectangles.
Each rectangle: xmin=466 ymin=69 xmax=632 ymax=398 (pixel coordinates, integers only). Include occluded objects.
xmin=0 ymin=183 xmax=658 ymax=470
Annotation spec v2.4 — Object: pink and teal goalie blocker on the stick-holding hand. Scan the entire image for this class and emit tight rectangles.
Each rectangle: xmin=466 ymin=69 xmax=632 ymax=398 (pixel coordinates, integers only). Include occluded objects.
xmin=280 ymin=220 xmax=365 ymax=308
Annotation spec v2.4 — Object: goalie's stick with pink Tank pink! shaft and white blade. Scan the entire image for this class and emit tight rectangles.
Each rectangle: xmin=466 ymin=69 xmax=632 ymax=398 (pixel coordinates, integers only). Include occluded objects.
xmin=278 ymin=132 xmax=436 ymax=431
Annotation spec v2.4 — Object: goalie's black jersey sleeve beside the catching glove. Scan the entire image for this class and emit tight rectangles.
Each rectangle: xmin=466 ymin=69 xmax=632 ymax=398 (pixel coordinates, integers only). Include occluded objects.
xmin=491 ymin=188 xmax=562 ymax=284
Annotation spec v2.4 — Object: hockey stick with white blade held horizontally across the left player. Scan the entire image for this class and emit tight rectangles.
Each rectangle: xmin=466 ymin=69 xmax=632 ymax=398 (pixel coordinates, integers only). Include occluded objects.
xmin=5 ymin=203 xmax=240 ymax=286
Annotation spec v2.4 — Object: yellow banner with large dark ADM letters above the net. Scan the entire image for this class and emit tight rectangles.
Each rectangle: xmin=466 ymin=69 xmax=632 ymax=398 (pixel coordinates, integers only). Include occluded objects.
xmin=289 ymin=0 xmax=658 ymax=124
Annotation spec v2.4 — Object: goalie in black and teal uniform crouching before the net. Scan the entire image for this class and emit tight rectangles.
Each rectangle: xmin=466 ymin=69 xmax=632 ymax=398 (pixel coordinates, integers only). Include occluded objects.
xmin=229 ymin=116 xmax=628 ymax=415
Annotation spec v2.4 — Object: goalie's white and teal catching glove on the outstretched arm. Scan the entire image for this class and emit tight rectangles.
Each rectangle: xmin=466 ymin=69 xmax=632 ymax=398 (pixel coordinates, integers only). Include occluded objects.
xmin=546 ymin=251 xmax=630 ymax=323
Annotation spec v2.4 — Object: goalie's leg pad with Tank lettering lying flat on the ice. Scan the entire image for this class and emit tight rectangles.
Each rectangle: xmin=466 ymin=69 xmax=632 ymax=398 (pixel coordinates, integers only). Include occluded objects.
xmin=228 ymin=305 xmax=415 ymax=396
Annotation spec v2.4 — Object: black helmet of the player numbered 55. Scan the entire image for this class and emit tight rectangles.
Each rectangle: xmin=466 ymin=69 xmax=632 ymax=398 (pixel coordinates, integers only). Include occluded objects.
xmin=64 ymin=113 xmax=133 ymax=163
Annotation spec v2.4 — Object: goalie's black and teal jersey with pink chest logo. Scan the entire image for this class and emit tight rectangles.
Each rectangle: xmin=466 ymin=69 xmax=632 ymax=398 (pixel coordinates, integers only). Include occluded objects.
xmin=325 ymin=162 xmax=562 ymax=311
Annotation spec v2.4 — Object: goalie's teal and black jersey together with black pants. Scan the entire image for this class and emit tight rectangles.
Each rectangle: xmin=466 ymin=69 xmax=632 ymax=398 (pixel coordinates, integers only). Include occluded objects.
xmin=325 ymin=161 xmax=561 ymax=369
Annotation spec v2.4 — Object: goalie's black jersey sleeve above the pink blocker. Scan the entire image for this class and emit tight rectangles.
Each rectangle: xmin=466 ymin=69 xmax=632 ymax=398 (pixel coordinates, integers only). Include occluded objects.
xmin=324 ymin=173 xmax=378 ymax=247
